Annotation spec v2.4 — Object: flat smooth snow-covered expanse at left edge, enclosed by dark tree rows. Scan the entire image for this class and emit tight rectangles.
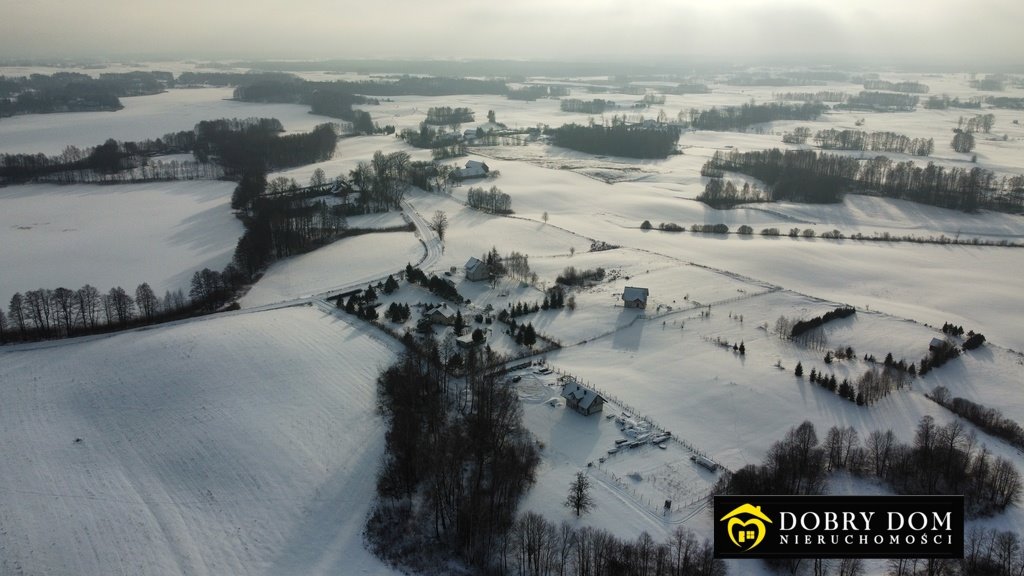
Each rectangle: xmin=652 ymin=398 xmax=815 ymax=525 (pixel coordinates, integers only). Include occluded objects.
xmin=0 ymin=181 xmax=243 ymax=307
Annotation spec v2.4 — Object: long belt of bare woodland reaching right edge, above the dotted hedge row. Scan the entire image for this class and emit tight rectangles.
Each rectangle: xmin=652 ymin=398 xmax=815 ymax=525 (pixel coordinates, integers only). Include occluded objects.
xmin=700 ymin=149 xmax=1024 ymax=212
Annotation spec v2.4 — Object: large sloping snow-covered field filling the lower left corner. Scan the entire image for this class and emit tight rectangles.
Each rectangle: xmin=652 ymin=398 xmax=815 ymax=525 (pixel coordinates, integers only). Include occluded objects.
xmin=0 ymin=306 xmax=398 ymax=576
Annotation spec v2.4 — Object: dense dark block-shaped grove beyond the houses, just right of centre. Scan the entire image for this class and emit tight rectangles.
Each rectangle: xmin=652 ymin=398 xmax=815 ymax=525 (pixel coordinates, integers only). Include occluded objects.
xmin=554 ymin=123 xmax=679 ymax=158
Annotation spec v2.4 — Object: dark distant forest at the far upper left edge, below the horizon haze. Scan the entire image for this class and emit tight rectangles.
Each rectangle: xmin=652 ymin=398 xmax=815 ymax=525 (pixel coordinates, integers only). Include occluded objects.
xmin=0 ymin=72 xmax=174 ymax=117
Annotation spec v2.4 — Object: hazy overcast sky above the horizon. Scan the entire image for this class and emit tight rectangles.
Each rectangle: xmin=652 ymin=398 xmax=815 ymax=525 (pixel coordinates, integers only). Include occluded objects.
xmin=0 ymin=0 xmax=1024 ymax=66
